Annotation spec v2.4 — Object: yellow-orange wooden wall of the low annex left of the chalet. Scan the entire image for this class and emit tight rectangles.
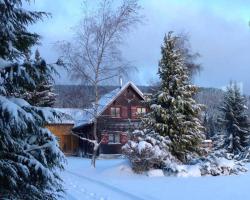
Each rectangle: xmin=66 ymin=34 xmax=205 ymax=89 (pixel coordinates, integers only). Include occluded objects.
xmin=46 ymin=124 xmax=79 ymax=155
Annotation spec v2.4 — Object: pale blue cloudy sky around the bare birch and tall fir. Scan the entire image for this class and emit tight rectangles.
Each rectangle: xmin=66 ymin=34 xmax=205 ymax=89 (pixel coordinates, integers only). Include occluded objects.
xmin=26 ymin=0 xmax=250 ymax=94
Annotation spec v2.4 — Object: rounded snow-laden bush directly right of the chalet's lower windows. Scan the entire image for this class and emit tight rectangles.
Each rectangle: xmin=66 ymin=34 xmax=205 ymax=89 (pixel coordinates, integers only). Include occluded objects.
xmin=122 ymin=130 xmax=176 ymax=173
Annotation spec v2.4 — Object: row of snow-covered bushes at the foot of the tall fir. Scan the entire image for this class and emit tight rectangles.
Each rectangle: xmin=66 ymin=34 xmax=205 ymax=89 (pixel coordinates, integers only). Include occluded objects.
xmin=122 ymin=130 xmax=247 ymax=177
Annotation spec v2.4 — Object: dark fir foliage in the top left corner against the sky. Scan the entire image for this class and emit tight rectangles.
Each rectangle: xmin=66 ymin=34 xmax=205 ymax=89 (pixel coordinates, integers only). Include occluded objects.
xmin=0 ymin=0 xmax=48 ymax=60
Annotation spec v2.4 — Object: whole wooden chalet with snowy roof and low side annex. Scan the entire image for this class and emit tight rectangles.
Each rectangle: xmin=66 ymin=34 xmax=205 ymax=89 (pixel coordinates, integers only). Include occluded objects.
xmin=49 ymin=82 xmax=147 ymax=155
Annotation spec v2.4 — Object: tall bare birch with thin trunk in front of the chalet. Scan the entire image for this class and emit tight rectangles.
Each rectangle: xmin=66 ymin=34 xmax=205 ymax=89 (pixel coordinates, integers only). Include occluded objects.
xmin=59 ymin=0 xmax=141 ymax=166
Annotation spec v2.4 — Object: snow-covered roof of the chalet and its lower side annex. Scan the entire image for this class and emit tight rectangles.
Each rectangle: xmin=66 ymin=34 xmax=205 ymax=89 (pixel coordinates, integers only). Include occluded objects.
xmin=51 ymin=82 xmax=144 ymax=127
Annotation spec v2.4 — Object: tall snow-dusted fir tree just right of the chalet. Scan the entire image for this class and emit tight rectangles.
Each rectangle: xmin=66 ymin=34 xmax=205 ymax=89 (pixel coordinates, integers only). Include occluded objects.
xmin=143 ymin=32 xmax=204 ymax=162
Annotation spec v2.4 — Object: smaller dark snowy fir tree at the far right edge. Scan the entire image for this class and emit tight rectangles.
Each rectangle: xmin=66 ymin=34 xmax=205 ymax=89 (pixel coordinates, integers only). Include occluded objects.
xmin=216 ymin=82 xmax=250 ymax=155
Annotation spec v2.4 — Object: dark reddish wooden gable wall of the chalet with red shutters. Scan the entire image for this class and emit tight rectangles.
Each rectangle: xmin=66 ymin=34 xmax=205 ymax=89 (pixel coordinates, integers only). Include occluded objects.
xmin=97 ymin=86 xmax=146 ymax=154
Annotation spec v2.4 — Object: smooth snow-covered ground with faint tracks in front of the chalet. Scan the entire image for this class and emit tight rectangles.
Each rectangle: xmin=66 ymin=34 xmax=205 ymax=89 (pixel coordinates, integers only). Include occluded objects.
xmin=62 ymin=157 xmax=250 ymax=200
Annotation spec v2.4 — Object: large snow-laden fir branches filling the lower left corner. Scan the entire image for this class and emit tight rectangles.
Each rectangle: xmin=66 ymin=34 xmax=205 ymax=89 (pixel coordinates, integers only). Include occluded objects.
xmin=0 ymin=96 xmax=64 ymax=200
